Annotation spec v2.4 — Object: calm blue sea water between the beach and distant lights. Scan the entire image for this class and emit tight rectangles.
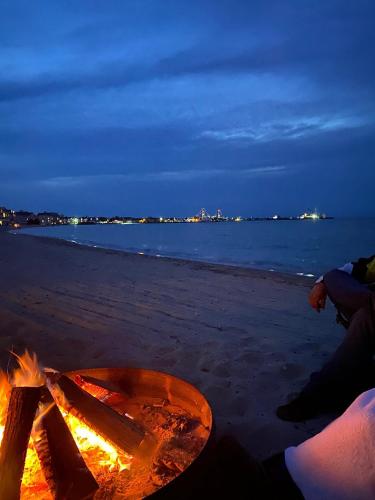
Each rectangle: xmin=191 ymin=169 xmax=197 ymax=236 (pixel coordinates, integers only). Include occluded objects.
xmin=22 ymin=219 xmax=375 ymax=276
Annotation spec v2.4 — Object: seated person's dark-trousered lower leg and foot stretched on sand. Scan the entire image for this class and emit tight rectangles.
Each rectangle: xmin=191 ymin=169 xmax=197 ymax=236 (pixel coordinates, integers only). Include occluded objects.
xmin=277 ymin=299 xmax=375 ymax=420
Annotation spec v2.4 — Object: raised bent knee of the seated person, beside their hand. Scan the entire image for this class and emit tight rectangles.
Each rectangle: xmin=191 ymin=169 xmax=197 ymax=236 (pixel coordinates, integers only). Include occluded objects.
xmin=324 ymin=269 xmax=371 ymax=320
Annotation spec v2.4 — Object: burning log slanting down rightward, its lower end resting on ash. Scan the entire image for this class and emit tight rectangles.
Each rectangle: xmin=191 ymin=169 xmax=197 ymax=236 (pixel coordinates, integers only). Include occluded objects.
xmin=51 ymin=375 xmax=146 ymax=455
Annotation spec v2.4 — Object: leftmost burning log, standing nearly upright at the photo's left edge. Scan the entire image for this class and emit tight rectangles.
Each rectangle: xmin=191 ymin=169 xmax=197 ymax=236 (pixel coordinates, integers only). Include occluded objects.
xmin=0 ymin=387 xmax=41 ymax=500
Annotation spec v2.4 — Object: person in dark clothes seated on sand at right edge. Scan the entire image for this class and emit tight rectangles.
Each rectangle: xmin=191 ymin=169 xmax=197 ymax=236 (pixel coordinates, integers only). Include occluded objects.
xmin=277 ymin=255 xmax=375 ymax=421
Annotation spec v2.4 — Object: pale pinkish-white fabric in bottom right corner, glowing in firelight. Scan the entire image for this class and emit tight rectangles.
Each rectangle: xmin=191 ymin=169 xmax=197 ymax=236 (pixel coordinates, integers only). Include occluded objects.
xmin=285 ymin=389 xmax=375 ymax=500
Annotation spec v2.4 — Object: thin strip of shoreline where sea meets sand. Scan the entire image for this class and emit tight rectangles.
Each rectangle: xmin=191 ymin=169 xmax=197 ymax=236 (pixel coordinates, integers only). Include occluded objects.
xmin=15 ymin=226 xmax=317 ymax=285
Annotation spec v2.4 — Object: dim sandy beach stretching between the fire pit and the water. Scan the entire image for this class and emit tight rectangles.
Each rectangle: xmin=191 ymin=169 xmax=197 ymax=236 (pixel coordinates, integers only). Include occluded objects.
xmin=0 ymin=232 xmax=343 ymax=458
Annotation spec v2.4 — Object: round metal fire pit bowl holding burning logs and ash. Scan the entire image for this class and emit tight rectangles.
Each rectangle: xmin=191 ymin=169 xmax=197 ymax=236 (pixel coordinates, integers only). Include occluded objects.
xmin=0 ymin=354 xmax=212 ymax=500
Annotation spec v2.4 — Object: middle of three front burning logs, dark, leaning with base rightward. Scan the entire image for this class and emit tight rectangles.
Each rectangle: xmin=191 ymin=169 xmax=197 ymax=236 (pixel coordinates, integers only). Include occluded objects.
xmin=33 ymin=389 xmax=99 ymax=500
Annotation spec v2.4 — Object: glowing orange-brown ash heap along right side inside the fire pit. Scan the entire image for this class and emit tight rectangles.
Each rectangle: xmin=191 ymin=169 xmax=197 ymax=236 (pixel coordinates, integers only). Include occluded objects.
xmin=95 ymin=397 xmax=209 ymax=500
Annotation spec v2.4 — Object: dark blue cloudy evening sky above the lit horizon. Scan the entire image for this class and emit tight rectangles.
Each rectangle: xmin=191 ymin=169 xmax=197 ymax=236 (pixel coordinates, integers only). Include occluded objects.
xmin=0 ymin=0 xmax=375 ymax=216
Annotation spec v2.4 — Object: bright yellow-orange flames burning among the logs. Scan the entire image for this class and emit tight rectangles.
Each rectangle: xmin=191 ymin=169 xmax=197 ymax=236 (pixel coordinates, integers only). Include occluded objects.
xmin=0 ymin=351 xmax=132 ymax=499
